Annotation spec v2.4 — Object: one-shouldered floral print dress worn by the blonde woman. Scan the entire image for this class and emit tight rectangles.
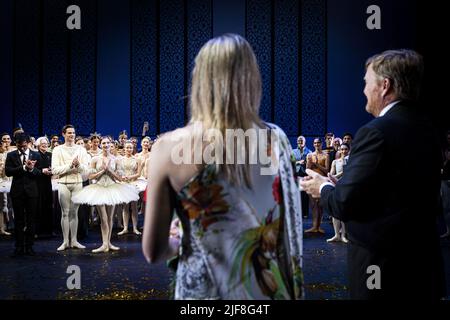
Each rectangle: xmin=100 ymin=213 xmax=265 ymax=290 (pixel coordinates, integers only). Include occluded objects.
xmin=174 ymin=124 xmax=303 ymax=299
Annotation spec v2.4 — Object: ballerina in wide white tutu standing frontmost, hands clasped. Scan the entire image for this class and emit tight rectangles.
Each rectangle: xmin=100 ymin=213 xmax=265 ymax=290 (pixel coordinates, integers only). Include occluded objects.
xmin=72 ymin=137 xmax=139 ymax=253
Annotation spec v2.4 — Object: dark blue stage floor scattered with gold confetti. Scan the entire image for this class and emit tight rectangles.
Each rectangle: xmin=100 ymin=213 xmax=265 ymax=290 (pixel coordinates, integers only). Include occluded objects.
xmin=0 ymin=219 xmax=450 ymax=300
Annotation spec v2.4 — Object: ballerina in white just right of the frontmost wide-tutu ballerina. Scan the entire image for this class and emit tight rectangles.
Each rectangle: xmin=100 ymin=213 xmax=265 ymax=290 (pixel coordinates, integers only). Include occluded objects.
xmin=117 ymin=140 xmax=147 ymax=236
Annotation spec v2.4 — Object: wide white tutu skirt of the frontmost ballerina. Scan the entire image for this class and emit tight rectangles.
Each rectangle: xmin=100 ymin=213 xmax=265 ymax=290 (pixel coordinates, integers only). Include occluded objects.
xmin=72 ymin=183 xmax=139 ymax=206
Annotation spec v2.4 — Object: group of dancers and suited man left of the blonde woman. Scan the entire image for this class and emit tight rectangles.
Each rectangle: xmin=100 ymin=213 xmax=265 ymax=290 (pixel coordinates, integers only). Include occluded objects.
xmin=0 ymin=124 xmax=153 ymax=255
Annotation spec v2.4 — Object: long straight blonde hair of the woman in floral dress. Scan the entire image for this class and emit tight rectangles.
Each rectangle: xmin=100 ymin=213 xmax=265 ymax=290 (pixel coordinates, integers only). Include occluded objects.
xmin=190 ymin=34 xmax=264 ymax=187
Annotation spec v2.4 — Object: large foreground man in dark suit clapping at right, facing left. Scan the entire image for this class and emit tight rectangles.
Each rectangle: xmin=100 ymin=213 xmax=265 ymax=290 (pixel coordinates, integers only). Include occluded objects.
xmin=301 ymin=50 xmax=445 ymax=299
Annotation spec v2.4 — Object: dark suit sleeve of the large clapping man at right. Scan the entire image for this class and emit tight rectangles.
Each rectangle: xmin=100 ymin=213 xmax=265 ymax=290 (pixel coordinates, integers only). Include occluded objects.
xmin=320 ymin=127 xmax=385 ymax=222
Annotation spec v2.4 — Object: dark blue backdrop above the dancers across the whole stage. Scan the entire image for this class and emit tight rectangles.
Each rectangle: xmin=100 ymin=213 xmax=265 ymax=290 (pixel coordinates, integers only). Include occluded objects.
xmin=0 ymin=0 xmax=450 ymax=146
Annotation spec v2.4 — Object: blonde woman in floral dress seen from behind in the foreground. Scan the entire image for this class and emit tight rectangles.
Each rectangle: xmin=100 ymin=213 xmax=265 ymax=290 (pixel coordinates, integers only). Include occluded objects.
xmin=143 ymin=34 xmax=302 ymax=299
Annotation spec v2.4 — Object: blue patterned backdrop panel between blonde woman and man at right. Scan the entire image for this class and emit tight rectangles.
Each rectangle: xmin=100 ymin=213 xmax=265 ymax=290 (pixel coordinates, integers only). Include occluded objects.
xmin=246 ymin=0 xmax=327 ymax=145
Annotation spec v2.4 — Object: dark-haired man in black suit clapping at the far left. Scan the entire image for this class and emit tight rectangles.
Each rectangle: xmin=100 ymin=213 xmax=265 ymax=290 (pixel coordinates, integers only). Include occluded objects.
xmin=5 ymin=133 xmax=41 ymax=256
